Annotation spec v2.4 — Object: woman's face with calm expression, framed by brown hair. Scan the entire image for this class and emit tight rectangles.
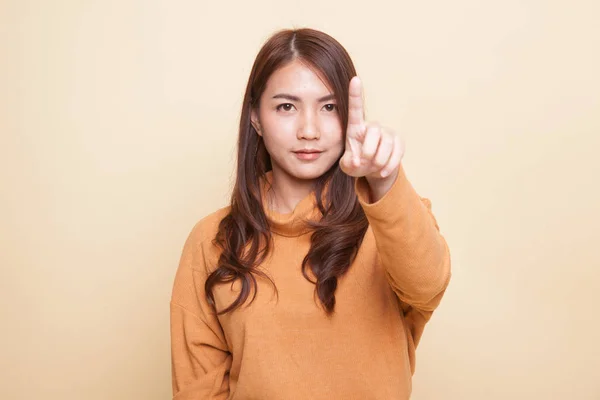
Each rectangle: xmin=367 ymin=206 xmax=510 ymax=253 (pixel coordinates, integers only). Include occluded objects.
xmin=252 ymin=61 xmax=344 ymax=180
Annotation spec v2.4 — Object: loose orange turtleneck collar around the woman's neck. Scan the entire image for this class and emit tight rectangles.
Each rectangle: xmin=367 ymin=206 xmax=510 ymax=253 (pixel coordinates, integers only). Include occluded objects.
xmin=261 ymin=171 xmax=322 ymax=237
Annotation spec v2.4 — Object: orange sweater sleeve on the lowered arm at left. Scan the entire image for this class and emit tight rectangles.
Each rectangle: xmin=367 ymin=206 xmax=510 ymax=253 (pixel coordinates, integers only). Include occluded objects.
xmin=170 ymin=223 xmax=231 ymax=400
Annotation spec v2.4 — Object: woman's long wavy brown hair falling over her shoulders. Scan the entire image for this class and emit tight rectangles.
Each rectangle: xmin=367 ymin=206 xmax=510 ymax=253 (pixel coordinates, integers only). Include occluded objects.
xmin=205 ymin=28 xmax=368 ymax=315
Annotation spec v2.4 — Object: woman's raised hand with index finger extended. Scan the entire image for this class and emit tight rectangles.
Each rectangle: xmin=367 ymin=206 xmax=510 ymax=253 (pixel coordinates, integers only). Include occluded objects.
xmin=340 ymin=76 xmax=404 ymax=181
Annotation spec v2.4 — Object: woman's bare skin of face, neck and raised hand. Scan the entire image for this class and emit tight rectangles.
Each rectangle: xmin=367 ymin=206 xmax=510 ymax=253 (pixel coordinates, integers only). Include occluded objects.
xmin=251 ymin=60 xmax=404 ymax=213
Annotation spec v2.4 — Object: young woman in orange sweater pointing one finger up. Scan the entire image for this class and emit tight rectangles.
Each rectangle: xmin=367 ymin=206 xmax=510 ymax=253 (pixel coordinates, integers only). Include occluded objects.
xmin=171 ymin=29 xmax=450 ymax=400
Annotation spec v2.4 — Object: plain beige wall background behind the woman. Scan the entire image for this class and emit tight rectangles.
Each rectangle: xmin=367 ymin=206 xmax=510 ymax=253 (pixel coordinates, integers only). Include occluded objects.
xmin=0 ymin=0 xmax=600 ymax=400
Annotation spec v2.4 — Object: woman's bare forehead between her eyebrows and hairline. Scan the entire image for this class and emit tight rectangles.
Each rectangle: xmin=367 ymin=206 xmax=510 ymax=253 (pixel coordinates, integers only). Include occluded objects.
xmin=265 ymin=60 xmax=332 ymax=97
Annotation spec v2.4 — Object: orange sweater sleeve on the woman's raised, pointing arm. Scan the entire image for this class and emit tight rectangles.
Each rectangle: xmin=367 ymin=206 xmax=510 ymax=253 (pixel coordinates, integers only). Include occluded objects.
xmin=355 ymin=165 xmax=451 ymax=346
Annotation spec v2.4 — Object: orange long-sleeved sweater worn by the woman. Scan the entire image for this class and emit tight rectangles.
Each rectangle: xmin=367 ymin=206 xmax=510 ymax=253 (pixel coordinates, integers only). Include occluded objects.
xmin=171 ymin=167 xmax=450 ymax=400
